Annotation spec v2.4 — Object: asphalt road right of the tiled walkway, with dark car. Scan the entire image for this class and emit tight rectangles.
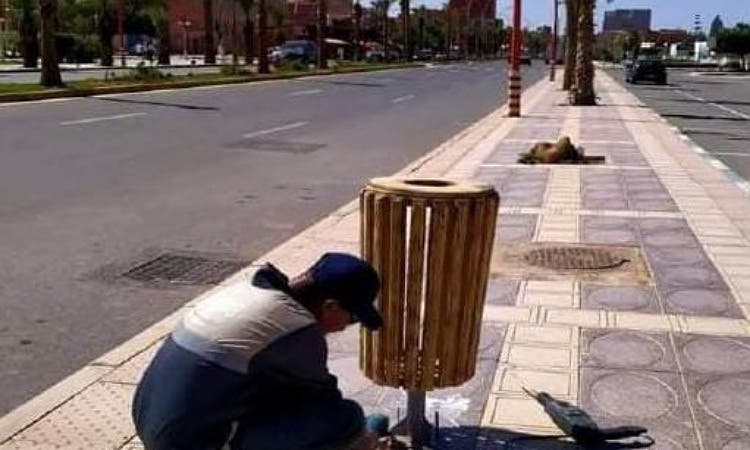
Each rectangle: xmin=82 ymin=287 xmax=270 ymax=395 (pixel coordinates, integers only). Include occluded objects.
xmin=610 ymin=69 xmax=750 ymax=180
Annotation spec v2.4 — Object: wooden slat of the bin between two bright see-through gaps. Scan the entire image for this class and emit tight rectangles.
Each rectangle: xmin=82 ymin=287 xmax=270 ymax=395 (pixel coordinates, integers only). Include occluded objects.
xmin=404 ymin=200 xmax=427 ymax=389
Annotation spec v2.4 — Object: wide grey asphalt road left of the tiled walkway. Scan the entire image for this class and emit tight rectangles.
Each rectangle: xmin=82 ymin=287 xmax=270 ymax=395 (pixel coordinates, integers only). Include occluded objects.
xmin=0 ymin=62 xmax=543 ymax=413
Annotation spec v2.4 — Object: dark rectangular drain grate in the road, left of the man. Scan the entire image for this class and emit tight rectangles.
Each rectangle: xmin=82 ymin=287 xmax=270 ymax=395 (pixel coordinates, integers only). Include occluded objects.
xmin=123 ymin=253 xmax=245 ymax=285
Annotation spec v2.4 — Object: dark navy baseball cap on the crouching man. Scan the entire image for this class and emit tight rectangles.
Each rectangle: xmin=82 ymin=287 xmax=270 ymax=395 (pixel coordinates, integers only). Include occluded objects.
xmin=308 ymin=253 xmax=383 ymax=330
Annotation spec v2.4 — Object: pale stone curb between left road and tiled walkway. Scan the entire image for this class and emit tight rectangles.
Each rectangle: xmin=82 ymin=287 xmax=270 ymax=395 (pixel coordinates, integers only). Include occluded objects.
xmin=0 ymin=72 xmax=547 ymax=445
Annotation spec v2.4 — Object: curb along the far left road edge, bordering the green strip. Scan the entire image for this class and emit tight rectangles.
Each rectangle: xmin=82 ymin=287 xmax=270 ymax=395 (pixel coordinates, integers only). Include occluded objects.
xmin=0 ymin=63 xmax=425 ymax=104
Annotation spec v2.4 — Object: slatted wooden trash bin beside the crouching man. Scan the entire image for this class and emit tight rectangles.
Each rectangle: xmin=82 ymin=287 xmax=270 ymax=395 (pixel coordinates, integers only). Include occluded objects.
xmin=360 ymin=178 xmax=499 ymax=392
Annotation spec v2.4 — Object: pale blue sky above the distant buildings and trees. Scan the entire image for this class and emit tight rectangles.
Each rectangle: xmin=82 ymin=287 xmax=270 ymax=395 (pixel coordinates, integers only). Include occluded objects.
xmin=412 ymin=0 xmax=750 ymax=32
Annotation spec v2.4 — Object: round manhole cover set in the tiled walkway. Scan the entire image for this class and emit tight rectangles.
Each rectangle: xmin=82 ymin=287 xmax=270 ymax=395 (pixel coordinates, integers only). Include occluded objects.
xmin=524 ymin=247 xmax=629 ymax=270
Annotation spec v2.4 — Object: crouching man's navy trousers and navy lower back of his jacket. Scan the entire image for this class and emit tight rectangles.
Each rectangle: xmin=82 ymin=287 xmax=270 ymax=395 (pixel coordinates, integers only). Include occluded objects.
xmin=133 ymin=338 xmax=364 ymax=450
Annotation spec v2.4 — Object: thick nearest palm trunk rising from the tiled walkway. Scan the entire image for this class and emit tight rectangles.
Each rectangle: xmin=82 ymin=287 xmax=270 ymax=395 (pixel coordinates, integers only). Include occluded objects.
xmin=571 ymin=0 xmax=596 ymax=105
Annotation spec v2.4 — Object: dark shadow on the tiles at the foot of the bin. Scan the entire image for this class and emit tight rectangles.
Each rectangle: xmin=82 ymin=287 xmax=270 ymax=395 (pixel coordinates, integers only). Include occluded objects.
xmin=431 ymin=426 xmax=653 ymax=450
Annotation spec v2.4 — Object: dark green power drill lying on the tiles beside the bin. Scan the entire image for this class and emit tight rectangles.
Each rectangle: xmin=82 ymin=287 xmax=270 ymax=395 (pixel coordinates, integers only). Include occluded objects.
xmin=523 ymin=387 xmax=654 ymax=448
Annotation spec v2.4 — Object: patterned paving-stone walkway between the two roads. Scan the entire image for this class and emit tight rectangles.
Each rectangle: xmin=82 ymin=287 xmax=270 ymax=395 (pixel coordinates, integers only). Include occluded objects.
xmin=0 ymin=71 xmax=750 ymax=450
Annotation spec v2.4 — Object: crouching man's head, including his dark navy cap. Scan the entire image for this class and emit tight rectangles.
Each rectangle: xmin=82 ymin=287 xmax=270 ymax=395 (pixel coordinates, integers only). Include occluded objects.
xmin=289 ymin=253 xmax=383 ymax=333
